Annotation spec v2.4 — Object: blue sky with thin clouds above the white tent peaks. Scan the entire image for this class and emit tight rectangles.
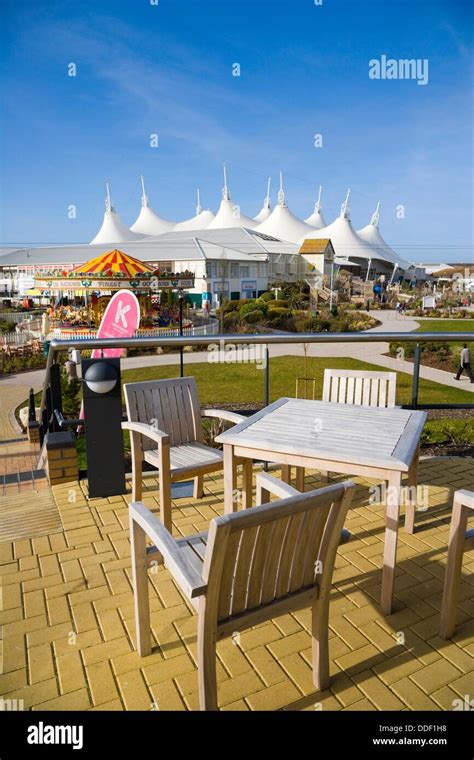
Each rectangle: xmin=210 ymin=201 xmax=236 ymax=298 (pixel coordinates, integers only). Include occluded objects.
xmin=0 ymin=0 xmax=473 ymax=261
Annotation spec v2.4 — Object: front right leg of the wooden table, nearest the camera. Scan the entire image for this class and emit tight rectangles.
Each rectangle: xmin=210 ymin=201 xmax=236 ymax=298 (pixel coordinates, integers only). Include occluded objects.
xmin=380 ymin=472 xmax=402 ymax=615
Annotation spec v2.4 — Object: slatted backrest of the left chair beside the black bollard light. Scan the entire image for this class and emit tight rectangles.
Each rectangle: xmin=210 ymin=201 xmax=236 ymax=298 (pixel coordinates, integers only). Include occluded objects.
xmin=124 ymin=377 xmax=203 ymax=451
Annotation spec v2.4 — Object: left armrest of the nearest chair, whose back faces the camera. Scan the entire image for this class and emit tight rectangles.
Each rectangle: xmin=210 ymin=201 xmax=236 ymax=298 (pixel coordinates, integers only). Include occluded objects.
xmin=130 ymin=501 xmax=207 ymax=599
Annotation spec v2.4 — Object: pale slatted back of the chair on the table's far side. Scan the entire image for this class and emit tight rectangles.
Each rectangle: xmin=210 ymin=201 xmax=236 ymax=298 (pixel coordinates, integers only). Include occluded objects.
xmin=323 ymin=369 xmax=397 ymax=407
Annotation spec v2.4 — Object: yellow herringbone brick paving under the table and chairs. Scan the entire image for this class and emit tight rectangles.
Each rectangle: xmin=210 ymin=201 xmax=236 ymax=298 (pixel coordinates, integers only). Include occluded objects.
xmin=0 ymin=458 xmax=474 ymax=710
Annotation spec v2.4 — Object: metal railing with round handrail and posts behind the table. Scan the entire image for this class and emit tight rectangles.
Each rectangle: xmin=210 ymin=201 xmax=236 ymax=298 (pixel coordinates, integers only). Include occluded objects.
xmin=41 ymin=332 xmax=474 ymax=428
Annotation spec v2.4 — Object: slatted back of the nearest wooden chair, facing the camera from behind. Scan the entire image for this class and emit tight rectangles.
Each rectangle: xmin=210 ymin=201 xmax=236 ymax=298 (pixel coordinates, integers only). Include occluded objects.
xmin=203 ymin=481 xmax=353 ymax=622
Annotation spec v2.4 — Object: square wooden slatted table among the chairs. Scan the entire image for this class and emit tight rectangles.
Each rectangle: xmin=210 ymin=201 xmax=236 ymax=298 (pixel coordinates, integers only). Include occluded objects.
xmin=216 ymin=398 xmax=427 ymax=615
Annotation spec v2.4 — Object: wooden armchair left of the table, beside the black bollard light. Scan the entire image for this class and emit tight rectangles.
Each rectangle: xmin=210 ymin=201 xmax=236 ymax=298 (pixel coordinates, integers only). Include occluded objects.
xmin=122 ymin=377 xmax=252 ymax=531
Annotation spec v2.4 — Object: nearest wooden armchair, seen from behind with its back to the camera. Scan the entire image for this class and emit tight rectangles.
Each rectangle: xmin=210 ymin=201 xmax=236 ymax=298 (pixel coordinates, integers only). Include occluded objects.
xmin=130 ymin=476 xmax=354 ymax=710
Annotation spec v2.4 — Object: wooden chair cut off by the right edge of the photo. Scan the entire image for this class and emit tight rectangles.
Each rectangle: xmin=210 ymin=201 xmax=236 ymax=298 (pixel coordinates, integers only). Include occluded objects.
xmin=439 ymin=490 xmax=474 ymax=639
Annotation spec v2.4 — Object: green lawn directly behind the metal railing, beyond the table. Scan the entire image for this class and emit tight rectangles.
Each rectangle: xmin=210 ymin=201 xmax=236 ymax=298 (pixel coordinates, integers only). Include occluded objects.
xmin=123 ymin=356 xmax=474 ymax=405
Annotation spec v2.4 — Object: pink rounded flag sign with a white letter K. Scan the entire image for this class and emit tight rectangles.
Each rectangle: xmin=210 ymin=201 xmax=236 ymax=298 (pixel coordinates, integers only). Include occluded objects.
xmin=92 ymin=290 xmax=140 ymax=359
